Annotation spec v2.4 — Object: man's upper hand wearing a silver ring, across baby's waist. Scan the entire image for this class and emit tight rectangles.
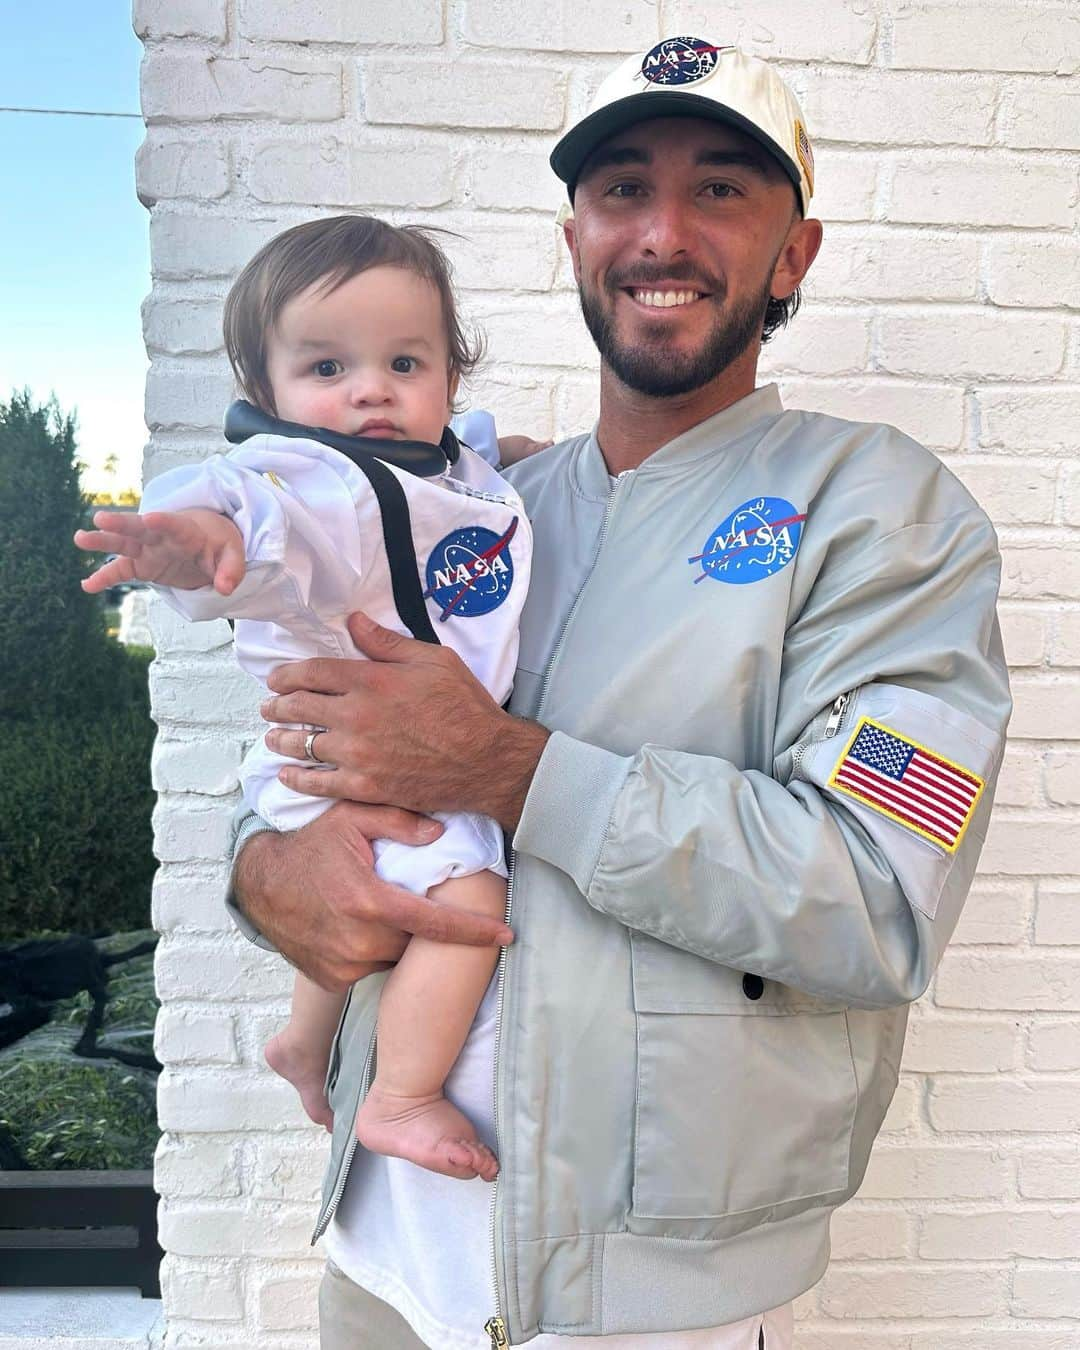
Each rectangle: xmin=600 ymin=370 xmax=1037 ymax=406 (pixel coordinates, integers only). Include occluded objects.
xmin=262 ymin=614 xmax=548 ymax=829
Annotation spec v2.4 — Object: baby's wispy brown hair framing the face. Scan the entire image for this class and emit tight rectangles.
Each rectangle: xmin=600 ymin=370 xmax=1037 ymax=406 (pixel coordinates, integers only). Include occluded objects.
xmin=224 ymin=216 xmax=482 ymax=413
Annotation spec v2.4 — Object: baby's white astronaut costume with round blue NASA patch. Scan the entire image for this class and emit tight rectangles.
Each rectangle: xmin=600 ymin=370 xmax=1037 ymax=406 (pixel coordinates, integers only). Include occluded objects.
xmin=140 ymin=413 xmax=532 ymax=895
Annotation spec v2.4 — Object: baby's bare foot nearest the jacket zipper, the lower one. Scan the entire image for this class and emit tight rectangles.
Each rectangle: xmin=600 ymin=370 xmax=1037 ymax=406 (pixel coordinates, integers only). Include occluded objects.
xmin=356 ymin=1080 xmax=498 ymax=1181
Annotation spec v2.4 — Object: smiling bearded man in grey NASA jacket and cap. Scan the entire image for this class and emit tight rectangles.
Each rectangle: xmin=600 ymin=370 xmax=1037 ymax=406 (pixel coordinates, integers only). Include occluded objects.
xmin=229 ymin=38 xmax=1010 ymax=1350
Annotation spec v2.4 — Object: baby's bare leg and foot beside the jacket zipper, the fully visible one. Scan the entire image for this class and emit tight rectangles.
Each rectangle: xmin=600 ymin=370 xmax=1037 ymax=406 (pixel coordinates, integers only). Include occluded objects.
xmin=356 ymin=872 xmax=506 ymax=1181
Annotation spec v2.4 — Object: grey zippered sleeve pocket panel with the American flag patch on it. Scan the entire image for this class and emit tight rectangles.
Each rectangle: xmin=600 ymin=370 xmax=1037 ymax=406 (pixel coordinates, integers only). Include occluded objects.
xmin=797 ymin=683 xmax=1002 ymax=918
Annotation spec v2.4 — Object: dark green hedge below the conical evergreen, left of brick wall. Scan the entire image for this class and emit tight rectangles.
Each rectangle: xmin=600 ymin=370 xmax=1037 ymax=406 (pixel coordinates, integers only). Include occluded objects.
xmin=0 ymin=648 xmax=155 ymax=941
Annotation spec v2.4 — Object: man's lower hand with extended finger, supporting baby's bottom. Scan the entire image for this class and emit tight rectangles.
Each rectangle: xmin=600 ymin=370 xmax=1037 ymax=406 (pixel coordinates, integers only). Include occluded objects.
xmin=234 ymin=802 xmax=513 ymax=992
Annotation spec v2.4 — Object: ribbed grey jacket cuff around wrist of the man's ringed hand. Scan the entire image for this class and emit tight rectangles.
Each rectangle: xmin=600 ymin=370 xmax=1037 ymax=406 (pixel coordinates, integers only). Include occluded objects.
xmin=513 ymin=732 xmax=633 ymax=895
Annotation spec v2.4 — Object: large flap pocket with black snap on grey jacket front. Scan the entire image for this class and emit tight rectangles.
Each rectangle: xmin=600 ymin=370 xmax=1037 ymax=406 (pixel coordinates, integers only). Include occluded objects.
xmin=630 ymin=932 xmax=857 ymax=1219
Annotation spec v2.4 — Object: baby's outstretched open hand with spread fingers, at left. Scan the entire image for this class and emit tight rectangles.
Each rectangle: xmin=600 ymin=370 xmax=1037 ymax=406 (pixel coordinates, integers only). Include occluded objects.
xmin=74 ymin=509 xmax=247 ymax=595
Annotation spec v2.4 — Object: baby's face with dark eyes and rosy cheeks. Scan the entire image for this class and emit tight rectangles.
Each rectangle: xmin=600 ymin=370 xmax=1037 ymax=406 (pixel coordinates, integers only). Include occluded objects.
xmin=267 ymin=267 xmax=456 ymax=444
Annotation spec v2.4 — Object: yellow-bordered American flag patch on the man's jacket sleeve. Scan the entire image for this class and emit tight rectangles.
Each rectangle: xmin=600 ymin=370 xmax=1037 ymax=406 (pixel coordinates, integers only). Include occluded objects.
xmin=828 ymin=717 xmax=983 ymax=853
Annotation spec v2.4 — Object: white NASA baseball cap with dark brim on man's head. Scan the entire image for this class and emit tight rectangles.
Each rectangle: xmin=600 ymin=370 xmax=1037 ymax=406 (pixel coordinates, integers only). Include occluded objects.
xmin=551 ymin=38 xmax=814 ymax=215
